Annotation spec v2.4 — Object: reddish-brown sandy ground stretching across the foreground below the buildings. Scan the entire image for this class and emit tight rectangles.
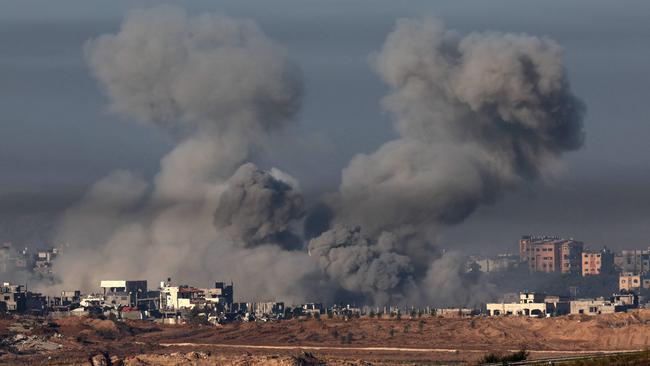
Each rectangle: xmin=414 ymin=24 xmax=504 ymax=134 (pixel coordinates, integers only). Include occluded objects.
xmin=0 ymin=310 xmax=650 ymax=365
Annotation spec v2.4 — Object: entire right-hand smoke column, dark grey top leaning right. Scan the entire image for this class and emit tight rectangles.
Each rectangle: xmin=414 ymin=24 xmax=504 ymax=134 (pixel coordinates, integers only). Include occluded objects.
xmin=309 ymin=19 xmax=583 ymax=301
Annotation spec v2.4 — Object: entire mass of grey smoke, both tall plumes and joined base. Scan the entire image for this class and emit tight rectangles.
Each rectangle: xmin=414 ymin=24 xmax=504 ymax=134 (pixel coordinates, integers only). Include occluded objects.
xmin=49 ymin=7 xmax=583 ymax=304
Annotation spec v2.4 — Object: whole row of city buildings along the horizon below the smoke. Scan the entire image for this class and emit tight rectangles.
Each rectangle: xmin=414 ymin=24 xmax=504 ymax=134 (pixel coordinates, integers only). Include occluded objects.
xmin=0 ymin=235 xmax=650 ymax=322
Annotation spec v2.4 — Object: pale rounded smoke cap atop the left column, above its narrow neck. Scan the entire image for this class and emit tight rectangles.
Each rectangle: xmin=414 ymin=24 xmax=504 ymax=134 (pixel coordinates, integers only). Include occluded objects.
xmin=85 ymin=6 xmax=302 ymax=134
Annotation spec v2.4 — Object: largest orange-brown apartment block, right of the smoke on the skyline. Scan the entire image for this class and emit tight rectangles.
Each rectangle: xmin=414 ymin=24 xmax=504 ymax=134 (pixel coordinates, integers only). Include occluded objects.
xmin=519 ymin=236 xmax=583 ymax=273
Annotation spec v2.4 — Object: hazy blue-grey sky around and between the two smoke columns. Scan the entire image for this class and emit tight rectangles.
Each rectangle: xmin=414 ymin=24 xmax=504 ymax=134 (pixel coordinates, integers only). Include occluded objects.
xmin=0 ymin=0 xmax=650 ymax=254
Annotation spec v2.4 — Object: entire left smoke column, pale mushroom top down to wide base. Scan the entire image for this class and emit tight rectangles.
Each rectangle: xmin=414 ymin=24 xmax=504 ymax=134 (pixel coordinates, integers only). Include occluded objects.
xmin=50 ymin=7 xmax=322 ymax=301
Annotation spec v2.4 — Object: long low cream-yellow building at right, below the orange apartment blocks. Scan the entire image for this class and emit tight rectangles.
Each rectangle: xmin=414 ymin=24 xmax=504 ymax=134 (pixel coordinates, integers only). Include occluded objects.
xmin=486 ymin=292 xmax=569 ymax=317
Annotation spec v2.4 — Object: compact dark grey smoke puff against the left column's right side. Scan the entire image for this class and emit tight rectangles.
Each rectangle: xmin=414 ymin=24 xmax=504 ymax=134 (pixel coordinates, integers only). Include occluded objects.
xmin=214 ymin=163 xmax=304 ymax=249
